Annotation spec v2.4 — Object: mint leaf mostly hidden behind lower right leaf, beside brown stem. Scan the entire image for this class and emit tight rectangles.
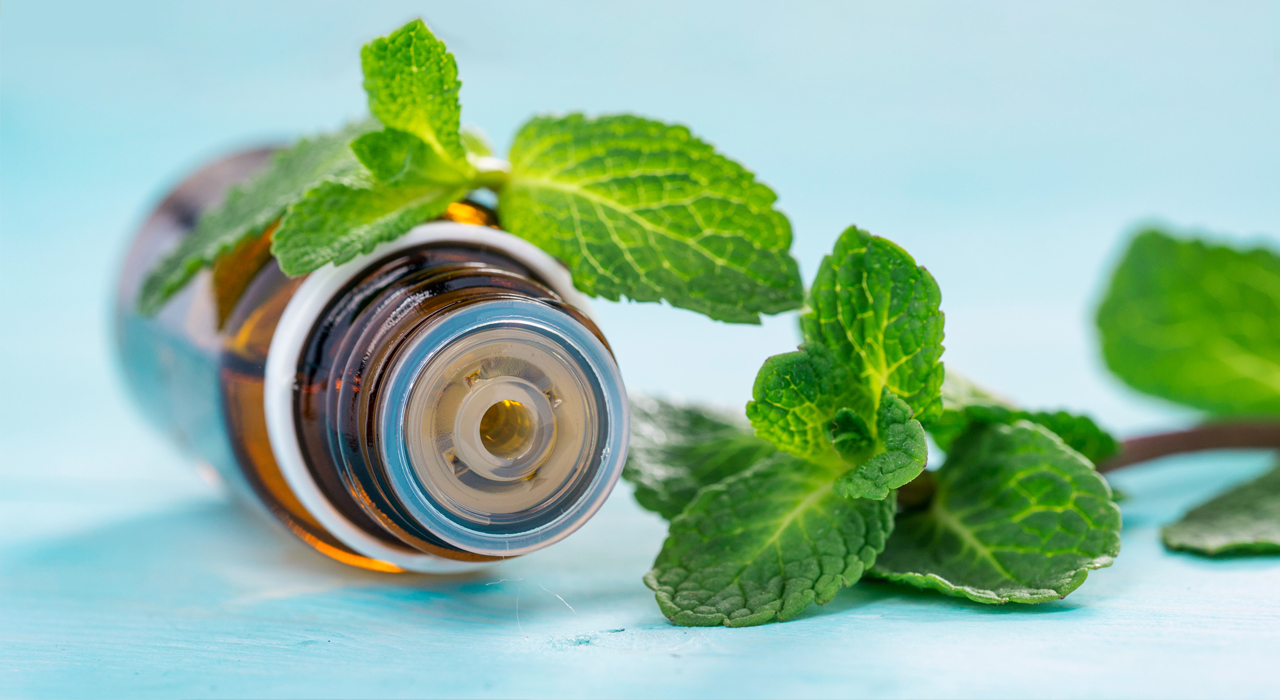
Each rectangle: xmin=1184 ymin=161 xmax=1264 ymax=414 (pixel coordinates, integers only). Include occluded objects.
xmin=928 ymin=370 xmax=1120 ymax=465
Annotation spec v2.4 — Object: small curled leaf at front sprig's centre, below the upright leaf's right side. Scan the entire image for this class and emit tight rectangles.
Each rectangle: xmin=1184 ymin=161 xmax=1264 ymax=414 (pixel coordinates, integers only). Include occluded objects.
xmin=836 ymin=388 xmax=929 ymax=500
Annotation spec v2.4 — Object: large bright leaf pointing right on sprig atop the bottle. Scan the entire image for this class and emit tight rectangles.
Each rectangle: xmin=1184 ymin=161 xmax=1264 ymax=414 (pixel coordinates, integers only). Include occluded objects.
xmin=498 ymin=114 xmax=803 ymax=324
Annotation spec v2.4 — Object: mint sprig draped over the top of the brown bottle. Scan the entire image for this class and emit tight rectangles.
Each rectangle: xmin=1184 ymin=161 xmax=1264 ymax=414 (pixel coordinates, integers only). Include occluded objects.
xmin=140 ymin=19 xmax=801 ymax=322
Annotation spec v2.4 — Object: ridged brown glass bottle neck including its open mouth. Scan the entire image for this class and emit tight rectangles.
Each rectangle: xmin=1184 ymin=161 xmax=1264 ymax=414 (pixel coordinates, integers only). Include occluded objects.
xmin=293 ymin=234 xmax=626 ymax=559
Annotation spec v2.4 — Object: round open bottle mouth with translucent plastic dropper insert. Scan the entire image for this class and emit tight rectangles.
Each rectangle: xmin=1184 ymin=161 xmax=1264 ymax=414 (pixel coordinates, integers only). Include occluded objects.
xmin=375 ymin=299 xmax=630 ymax=557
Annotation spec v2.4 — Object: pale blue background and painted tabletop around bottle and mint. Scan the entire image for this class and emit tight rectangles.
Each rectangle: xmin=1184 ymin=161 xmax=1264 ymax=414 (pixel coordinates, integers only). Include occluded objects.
xmin=0 ymin=0 xmax=1280 ymax=697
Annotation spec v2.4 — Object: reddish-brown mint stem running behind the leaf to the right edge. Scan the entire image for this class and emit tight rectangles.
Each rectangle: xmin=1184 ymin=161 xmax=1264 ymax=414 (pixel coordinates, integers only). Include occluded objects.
xmin=897 ymin=421 xmax=1280 ymax=511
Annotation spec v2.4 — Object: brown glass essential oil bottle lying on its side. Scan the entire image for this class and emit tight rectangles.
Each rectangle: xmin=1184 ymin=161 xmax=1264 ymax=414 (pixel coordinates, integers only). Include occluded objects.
xmin=115 ymin=150 xmax=630 ymax=573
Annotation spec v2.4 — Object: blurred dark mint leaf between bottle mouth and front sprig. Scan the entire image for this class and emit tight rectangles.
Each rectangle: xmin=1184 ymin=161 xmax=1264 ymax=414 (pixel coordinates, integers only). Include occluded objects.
xmin=622 ymin=397 xmax=777 ymax=520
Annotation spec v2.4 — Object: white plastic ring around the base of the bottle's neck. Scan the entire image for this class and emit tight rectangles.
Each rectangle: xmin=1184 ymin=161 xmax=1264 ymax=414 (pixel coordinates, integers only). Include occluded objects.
xmin=262 ymin=221 xmax=590 ymax=573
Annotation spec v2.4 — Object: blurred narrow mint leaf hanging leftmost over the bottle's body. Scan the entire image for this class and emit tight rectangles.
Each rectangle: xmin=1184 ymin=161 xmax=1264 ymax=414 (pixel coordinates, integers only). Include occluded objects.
xmin=138 ymin=120 xmax=378 ymax=315
